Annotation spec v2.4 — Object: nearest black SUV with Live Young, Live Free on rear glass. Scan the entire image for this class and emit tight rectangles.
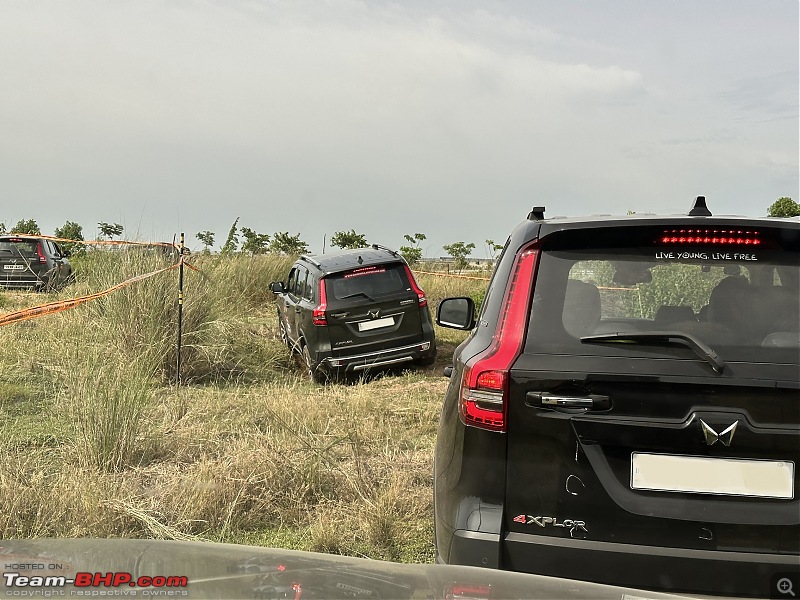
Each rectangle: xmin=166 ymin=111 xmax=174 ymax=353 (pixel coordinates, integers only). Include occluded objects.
xmin=434 ymin=197 xmax=800 ymax=597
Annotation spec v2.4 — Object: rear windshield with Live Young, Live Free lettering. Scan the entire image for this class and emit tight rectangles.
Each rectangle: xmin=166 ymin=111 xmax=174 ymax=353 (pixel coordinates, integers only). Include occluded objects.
xmin=527 ymin=226 xmax=800 ymax=363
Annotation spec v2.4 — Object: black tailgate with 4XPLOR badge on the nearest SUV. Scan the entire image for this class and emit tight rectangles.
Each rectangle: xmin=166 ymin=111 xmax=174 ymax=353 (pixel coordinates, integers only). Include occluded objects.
xmin=504 ymin=222 xmax=800 ymax=588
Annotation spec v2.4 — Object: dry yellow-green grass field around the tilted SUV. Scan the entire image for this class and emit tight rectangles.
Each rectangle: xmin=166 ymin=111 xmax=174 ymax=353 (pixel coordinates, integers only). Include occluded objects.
xmin=0 ymin=252 xmax=486 ymax=562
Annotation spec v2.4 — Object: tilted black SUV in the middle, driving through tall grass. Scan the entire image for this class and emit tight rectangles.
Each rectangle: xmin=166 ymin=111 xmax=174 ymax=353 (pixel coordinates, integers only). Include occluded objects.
xmin=270 ymin=245 xmax=436 ymax=382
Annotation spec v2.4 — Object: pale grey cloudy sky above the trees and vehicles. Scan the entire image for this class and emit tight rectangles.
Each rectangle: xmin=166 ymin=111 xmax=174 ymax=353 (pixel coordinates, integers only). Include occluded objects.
xmin=0 ymin=0 xmax=800 ymax=256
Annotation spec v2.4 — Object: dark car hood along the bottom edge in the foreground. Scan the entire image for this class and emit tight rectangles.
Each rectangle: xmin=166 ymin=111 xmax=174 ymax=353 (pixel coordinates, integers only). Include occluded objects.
xmin=0 ymin=539 xmax=708 ymax=600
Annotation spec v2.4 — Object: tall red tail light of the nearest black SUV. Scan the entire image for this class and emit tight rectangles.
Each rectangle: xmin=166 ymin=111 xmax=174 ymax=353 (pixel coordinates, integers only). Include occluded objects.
xmin=459 ymin=245 xmax=539 ymax=432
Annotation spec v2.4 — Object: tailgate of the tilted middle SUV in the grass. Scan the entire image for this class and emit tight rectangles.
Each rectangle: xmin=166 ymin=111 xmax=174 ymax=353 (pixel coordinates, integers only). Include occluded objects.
xmin=323 ymin=263 xmax=424 ymax=355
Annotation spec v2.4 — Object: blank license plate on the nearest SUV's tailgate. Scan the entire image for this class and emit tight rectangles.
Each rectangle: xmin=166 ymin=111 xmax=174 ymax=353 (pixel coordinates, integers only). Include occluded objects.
xmin=631 ymin=452 xmax=794 ymax=500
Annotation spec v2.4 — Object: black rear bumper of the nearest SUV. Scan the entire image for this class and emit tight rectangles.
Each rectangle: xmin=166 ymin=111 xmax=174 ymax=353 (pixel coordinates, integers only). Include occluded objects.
xmin=449 ymin=531 xmax=800 ymax=598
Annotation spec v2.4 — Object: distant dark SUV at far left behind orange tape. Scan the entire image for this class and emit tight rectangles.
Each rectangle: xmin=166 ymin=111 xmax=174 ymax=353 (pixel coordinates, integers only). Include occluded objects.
xmin=0 ymin=234 xmax=72 ymax=291
